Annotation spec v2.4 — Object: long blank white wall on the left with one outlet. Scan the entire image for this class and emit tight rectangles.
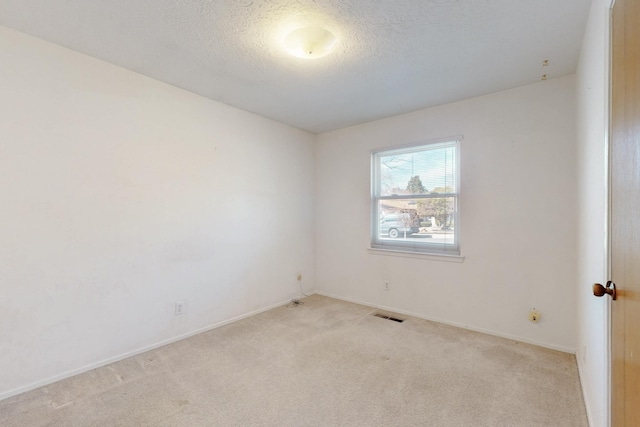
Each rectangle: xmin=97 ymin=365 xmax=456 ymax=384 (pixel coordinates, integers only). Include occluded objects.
xmin=0 ymin=27 xmax=315 ymax=398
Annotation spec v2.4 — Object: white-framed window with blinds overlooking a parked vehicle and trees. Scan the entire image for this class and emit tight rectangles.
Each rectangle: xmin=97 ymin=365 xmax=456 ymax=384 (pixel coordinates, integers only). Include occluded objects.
xmin=371 ymin=138 xmax=461 ymax=255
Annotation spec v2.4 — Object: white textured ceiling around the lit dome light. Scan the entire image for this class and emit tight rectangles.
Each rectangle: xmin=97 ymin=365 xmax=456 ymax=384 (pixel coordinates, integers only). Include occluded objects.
xmin=0 ymin=0 xmax=591 ymax=133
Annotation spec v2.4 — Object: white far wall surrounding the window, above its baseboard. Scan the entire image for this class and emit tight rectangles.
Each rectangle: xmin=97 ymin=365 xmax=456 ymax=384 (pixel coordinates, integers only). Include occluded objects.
xmin=316 ymin=76 xmax=576 ymax=352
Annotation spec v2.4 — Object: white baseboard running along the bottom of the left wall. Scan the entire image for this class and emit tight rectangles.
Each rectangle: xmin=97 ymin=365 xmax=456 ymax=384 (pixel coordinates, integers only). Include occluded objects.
xmin=0 ymin=293 xmax=298 ymax=400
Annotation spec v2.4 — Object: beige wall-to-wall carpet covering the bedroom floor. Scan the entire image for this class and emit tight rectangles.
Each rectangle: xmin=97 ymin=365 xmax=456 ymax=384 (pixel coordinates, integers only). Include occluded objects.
xmin=0 ymin=296 xmax=587 ymax=427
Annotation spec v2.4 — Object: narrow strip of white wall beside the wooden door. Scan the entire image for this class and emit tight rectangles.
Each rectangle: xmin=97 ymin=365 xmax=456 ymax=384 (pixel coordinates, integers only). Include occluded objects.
xmin=576 ymin=0 xmax=610 ymax=426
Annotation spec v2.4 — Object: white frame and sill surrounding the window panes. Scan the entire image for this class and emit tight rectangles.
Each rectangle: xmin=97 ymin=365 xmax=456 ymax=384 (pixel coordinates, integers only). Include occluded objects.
xmin=368 ymin=135 xmax=464 ymax=262
